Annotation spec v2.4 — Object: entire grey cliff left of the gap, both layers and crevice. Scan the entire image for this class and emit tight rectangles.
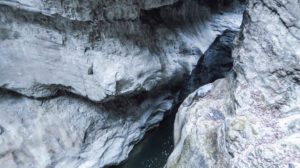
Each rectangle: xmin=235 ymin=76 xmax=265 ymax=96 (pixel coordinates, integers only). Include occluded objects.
xmin=0 ymin=0 xmax=243 ymax=168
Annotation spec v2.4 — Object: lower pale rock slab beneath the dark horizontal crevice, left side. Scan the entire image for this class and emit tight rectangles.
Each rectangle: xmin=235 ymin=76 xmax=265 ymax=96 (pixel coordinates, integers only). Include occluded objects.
xmin=0 ymin=88 xmax=172 ymax=168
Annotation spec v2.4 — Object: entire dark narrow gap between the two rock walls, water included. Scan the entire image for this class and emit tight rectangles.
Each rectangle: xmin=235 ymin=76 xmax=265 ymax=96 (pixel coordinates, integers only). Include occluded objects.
xmin=110 ymin=30 xmax=237 ymax=168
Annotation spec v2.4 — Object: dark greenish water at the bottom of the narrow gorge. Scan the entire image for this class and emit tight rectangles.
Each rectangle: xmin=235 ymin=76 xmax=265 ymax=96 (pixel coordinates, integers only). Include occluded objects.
xmin=117 ymin=113 xmax=175 ymax=168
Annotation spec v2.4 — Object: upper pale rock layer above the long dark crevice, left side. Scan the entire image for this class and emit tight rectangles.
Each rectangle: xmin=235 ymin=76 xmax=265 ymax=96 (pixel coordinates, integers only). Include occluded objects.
xmin=0 ymin=0 xmax=242 ymax=102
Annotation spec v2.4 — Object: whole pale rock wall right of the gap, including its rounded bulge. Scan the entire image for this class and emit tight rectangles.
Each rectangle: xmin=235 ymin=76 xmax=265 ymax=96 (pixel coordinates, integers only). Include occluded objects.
xmin=167 ymin=0 xmax=300 ymax=168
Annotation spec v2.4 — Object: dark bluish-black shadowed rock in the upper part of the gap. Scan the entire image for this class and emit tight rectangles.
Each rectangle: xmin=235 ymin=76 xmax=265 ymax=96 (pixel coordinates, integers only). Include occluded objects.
xmin=176 ymin=30 xmax=237 ymax=104
